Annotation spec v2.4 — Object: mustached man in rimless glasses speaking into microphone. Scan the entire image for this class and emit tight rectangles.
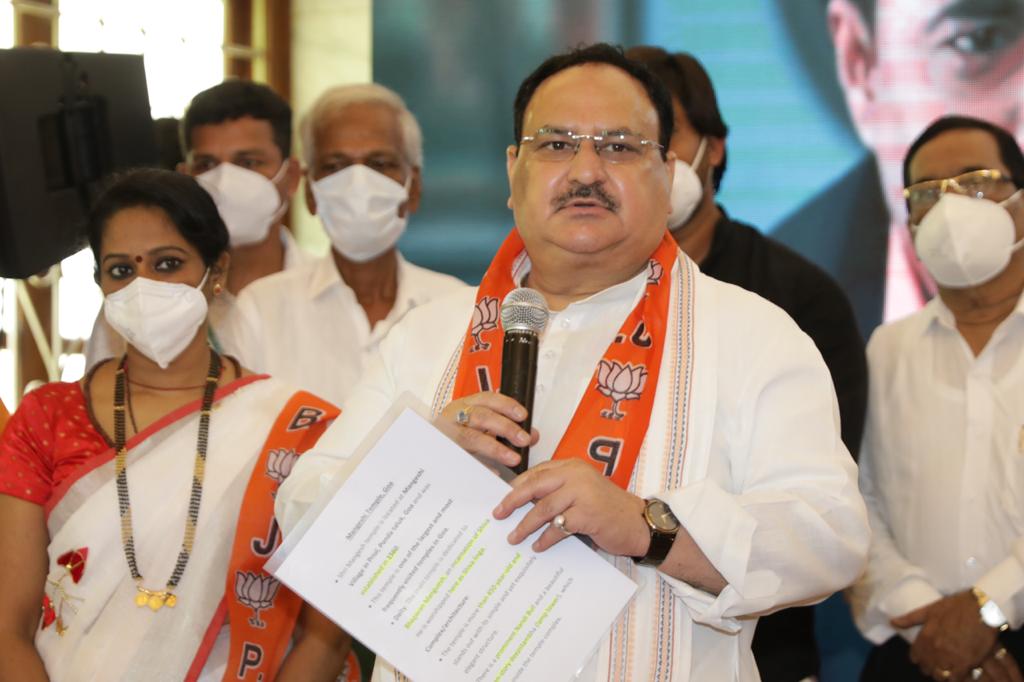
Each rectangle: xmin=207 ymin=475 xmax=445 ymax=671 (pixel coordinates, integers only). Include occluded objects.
xmin=276 ymin=44 xmax=868 ymax=682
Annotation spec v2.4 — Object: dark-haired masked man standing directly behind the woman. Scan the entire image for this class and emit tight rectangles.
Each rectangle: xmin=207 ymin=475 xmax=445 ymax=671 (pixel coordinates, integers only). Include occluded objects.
xmin=86 ymin=80 xmax=311 ymax=367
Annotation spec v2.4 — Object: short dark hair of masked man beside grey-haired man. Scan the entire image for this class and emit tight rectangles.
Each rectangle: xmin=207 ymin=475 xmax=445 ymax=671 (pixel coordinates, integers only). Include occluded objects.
xmin=181 ymin=79 xmax=292 ymax=159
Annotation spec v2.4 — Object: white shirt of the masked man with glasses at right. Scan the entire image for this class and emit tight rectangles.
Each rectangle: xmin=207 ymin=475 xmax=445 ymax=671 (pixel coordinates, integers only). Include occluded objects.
xmin=851 ymin=288 xmax=1024 ymax=643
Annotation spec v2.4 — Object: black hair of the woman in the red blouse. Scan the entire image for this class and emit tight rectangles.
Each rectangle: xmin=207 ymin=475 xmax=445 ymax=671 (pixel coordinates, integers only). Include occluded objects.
xmin=86 ymin=168 xmax=228 ymax=271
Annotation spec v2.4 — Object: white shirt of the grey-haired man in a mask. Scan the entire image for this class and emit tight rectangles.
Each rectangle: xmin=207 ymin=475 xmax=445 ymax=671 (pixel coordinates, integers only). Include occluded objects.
xmin=223 ymin=254 xmax=468 ymax=404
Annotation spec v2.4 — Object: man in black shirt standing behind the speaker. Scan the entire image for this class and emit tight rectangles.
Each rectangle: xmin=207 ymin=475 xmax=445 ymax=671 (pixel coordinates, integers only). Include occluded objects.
xmin=627 ymin=46 xmax=867 ymax=682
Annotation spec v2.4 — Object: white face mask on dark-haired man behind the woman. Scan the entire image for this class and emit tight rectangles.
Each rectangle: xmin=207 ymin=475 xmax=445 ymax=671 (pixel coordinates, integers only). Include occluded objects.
xmin=196 ymin=161 xmax=288 ymax=247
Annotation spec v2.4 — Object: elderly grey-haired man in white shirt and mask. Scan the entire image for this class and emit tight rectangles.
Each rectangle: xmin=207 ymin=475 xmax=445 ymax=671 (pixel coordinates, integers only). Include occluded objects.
xmin=228 ymin=84 xmax=465 ymax=404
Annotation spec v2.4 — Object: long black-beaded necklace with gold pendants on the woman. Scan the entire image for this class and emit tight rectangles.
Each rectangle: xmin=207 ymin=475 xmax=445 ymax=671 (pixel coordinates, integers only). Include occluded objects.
xmin=114 ymin=348 xmax=220 ymax=611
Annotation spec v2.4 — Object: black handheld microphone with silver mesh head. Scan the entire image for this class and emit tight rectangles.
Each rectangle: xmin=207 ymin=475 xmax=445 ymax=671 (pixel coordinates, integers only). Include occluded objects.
xmin=501 ymin=287 xmax=549 ymax=474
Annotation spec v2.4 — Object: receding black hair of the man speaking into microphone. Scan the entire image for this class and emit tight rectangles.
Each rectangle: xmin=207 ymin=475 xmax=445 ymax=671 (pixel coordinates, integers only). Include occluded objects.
xmin=512 ymin=43 xmax=672 ymax=158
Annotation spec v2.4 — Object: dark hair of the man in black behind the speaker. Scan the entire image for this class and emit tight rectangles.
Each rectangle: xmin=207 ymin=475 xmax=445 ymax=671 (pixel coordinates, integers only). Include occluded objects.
xmin=626 ymin=45 xmax=729 ymax=191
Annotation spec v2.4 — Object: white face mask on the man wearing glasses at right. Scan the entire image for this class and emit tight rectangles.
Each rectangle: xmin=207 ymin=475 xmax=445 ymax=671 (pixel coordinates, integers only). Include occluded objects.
xmin=913 ymin=189 xmax=1024 ymax=289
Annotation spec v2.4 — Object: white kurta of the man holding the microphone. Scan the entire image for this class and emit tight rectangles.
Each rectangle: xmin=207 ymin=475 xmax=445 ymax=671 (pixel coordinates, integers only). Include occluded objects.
xmin=276 ymin=254 xmax=868 ymax=682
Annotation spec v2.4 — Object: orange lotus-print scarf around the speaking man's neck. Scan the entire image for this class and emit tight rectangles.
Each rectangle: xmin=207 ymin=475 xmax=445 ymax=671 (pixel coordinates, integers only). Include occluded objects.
xmin=453 ymin=229 xmax=679 ymax=489
